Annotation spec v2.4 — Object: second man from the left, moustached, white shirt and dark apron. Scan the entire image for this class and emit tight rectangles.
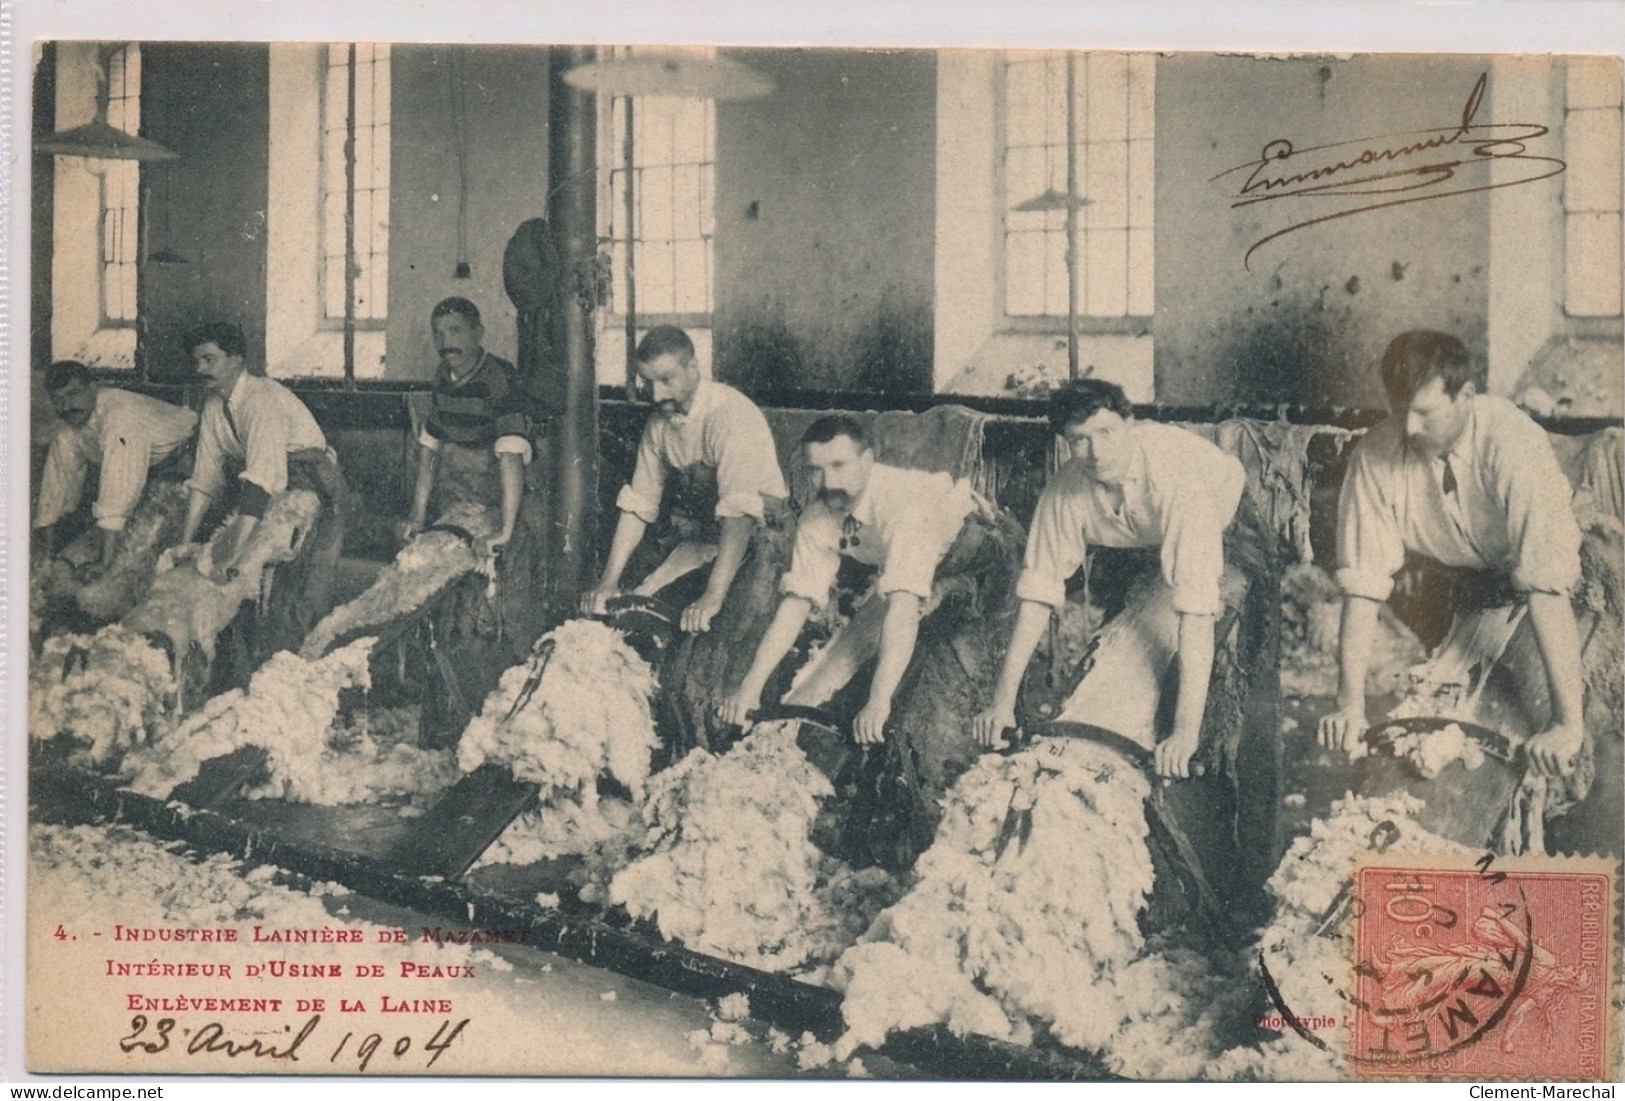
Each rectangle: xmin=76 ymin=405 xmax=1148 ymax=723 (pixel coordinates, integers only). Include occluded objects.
xmin=177 ymin=322 xmax=349 ymax=658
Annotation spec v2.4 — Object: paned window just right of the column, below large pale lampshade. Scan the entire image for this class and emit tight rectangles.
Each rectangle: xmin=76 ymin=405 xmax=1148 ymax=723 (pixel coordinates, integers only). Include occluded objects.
xmin=598 ymin=50 xmax=717 ymax=326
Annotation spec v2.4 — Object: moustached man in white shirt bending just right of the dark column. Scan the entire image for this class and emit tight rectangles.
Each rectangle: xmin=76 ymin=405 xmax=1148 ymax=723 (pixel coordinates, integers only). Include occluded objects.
xmin=580 ymin=325 xmax=790 ymax=633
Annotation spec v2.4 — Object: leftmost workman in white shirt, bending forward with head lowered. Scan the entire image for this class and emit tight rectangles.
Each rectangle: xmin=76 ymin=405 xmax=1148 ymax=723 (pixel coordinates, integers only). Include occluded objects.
xmin=34 ymin=359 xmax=198 ymax=570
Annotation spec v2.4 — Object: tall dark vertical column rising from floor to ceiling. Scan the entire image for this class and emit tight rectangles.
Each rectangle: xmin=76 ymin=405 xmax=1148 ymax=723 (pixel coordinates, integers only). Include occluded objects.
xmin=548 ymin=45 xmax=598 ymax=611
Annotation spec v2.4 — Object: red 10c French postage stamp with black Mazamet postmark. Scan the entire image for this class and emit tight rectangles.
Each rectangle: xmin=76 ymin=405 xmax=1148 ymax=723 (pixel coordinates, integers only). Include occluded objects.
xmin=1349 ymin=857 xmax=1615 ymax=1080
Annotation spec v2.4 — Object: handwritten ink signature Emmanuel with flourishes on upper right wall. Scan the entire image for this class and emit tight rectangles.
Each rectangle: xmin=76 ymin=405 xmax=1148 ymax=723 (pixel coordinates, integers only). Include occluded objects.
xmin=1209 ymin=73 xmax=1568 ymax=268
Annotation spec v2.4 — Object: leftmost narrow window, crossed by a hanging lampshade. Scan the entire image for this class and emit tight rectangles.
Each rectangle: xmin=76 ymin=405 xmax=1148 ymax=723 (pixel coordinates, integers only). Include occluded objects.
xmin=98 ymin=42 xmax=141 ymax=326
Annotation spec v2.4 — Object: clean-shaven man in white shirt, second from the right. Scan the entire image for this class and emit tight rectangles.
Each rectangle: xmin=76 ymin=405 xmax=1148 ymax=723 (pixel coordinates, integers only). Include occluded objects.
xmin=972 ymin=378 xmax=1246 ymax=778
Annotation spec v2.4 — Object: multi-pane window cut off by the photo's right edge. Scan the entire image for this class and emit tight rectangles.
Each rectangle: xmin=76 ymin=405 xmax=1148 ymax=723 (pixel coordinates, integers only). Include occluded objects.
xmin=1563 ymin=58 xmax=1620 ymax=318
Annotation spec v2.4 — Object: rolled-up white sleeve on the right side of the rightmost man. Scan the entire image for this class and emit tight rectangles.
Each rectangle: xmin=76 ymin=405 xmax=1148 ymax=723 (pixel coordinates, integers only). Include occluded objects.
xmin=1493 ymin=421 xmax=1581 ymax=593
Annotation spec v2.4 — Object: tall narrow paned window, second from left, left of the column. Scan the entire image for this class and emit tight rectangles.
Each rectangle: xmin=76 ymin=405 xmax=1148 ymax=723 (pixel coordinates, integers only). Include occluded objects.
xmin=320 ymin=42 xmax=390 ymax=328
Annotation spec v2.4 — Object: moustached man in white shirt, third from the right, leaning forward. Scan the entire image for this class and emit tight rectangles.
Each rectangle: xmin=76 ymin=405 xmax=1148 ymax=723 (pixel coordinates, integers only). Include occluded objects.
xmin=718 ymin=414 xmax=990 ymax=744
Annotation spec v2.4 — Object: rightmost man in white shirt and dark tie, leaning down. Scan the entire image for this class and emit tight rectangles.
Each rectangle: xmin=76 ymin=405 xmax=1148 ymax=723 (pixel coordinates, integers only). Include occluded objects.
xmin=1320 ymin=330 xmax=1584 ymax=775
